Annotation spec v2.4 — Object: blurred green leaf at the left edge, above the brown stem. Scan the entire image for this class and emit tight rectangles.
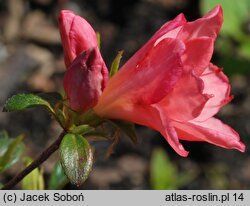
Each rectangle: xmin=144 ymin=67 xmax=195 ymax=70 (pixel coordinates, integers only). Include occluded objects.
xmin=0 ymin=135 xmax=24 ymax=172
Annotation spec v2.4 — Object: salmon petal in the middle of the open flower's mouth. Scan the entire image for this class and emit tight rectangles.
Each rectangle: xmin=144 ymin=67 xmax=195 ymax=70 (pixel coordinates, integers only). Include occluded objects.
xmin=157 ymin=72 xmax=209 ymax=121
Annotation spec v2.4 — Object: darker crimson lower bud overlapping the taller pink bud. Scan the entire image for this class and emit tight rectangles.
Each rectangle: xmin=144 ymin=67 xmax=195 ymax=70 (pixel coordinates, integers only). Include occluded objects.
xmin=63 ymin=47 xmax=106 ymax=112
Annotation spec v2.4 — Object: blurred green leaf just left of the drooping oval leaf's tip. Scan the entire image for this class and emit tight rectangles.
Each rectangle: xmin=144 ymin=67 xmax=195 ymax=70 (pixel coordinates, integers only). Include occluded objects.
xmin=48 ymin=162 xmax=69 ymax=190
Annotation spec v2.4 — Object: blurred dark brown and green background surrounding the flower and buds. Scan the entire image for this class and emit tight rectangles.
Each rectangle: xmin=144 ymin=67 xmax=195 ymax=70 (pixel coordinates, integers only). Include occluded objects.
xmin=0 ymin=0 xmax=250 ymax=189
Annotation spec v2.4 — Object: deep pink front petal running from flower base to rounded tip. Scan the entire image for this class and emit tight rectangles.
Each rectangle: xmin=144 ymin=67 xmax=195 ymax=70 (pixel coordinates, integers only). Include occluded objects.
xmin=95 ymin=39 xmax=184 ymax=114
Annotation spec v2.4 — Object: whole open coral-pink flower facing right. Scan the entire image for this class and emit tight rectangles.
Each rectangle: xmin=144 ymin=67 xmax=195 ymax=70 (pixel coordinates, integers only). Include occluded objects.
xmin=94 ymin=6 xmax=245 ymax=156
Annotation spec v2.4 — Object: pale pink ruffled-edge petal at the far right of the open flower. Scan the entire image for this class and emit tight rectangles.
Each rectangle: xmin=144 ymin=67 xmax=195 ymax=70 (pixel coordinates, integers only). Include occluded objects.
xmin=195 ymin=64 xmax=233 ymax=121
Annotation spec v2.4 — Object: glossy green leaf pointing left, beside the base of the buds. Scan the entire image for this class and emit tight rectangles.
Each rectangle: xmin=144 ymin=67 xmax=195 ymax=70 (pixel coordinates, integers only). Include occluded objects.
xmin=3 ymin=94 xmax=54 ymax=114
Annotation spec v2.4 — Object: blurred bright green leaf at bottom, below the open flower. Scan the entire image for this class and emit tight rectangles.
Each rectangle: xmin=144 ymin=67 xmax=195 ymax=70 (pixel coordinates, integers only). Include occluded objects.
xmin=150 ymin=148 xmax=178 ymax=190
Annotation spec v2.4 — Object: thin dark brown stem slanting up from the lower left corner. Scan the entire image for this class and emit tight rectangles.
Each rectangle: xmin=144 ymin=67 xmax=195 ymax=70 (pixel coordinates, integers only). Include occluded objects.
xmin=2 ymin=131 xmax=66 ymax=190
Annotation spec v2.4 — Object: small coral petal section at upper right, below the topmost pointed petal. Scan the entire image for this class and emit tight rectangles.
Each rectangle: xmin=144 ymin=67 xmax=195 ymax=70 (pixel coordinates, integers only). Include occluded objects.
xmin=182 ymin=37 xmax=214 ymax=76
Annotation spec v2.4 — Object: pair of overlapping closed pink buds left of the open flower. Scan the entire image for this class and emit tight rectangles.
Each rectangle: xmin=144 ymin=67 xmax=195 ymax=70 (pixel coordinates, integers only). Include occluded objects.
xmin=59 ymin=10 xmax=108 ymax=112
